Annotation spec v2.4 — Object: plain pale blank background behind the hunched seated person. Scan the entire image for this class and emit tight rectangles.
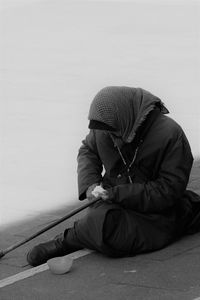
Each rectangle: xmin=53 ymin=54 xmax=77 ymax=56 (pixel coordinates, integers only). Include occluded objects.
xmin=0 ymin=0 xmax=200 ymax=222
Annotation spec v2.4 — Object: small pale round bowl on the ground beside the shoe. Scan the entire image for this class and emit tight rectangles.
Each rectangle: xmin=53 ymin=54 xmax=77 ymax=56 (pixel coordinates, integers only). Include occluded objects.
xmin=47 ymin=256 xmax=73 ymax=274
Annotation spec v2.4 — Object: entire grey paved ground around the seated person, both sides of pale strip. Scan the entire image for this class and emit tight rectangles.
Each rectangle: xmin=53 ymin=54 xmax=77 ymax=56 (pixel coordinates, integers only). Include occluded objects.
xmin=0 ymin=162 xmax=200 ymax=300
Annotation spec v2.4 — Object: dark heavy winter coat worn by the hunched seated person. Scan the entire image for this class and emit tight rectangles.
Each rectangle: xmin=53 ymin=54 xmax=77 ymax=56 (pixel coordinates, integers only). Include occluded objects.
xmin=78 ymin=89 xmax=200 ymax=255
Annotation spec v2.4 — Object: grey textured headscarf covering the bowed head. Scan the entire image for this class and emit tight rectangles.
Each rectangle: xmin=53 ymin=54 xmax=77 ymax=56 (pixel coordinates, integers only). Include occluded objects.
xmin=88 ymin=86 xmax=169 ymax=143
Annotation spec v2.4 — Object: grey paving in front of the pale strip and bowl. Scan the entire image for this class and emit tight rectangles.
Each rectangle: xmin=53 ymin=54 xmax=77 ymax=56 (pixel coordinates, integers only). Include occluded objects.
xmin=0 ymin=248 xmax=200 ymax=300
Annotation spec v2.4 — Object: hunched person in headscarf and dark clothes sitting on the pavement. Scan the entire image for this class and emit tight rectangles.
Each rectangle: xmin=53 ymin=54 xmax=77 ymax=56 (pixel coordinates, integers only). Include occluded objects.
xmin=27 ymin=86 xmax=200 ymax=266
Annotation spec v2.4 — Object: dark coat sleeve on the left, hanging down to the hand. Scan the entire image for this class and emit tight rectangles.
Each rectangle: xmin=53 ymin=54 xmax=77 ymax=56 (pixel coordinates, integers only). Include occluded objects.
xmin=77 ymin=130 xmax=103 ymax=200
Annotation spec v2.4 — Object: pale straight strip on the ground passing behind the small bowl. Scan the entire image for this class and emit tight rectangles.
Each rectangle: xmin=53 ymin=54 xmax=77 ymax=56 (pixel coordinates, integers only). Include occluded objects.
xmin=0 ymin=249 xmax=94 ymax=288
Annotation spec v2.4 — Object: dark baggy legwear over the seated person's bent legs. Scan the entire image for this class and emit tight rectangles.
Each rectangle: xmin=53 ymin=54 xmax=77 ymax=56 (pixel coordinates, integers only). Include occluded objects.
xmin=63 ymin=201 xmax=175 ymax=257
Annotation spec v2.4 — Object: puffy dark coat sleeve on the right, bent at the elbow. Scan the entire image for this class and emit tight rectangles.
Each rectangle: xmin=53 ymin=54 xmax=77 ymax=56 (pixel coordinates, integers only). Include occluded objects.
xmin=109 ymin=134 xmax=193 ymax=213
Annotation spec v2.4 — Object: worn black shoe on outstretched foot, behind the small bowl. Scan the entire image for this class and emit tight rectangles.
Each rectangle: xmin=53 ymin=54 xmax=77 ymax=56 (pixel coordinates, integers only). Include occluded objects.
xmin=27 ymin=237 xmax=70 ymax=267
